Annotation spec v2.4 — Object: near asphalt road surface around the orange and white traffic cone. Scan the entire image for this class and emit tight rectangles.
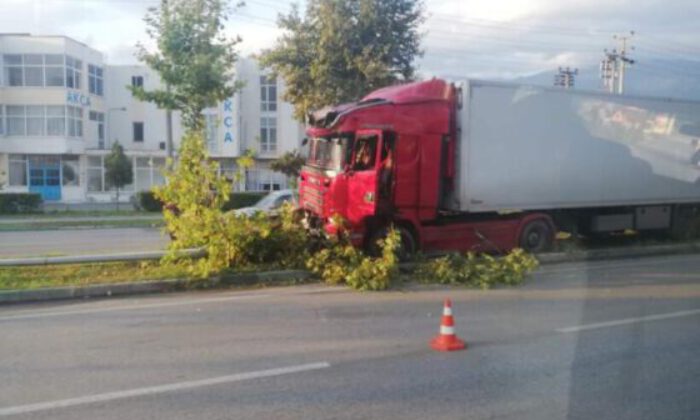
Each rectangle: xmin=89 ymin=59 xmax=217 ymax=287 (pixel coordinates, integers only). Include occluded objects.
xmin=0 ymin=256 xmax=700 ymax=420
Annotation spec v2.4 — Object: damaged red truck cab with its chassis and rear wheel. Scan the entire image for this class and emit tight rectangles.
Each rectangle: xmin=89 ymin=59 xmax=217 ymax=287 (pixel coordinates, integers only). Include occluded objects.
xmin=299 ymin=79 xmax=554 ymax=253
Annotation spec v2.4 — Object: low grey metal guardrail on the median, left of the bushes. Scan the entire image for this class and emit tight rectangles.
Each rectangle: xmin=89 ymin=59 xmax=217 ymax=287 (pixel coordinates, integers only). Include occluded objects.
xmin=0 ymin=248 xmax=206 ymax=267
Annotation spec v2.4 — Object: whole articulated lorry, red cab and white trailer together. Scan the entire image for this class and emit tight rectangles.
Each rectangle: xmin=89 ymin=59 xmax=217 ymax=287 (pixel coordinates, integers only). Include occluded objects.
xmin=299 ymin=79 xmax=700 ymax=256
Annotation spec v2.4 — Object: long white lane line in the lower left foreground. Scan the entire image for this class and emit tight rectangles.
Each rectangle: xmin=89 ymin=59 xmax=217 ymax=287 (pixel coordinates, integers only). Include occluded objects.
xmin=0 ymin=362 xmax=331 ymax=417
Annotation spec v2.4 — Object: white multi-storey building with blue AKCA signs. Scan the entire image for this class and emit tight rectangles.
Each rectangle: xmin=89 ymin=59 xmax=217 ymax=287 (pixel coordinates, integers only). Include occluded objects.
xmin=0 ymin=34 xmax=303 ymax=202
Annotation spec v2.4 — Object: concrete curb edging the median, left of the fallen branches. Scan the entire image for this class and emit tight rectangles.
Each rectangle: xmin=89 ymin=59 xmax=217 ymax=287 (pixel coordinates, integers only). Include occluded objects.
xmin=0 ymin=270 xmax=311 ymax=305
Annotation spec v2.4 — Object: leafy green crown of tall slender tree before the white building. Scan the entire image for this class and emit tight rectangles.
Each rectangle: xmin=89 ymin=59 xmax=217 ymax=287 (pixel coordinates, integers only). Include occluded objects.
xmin=128 ymin=0 xmax=240 ymax=130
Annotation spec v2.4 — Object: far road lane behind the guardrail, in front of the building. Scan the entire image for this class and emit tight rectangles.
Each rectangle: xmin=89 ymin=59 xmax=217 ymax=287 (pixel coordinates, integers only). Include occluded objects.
xmin=0 ymin=228 xmax=168 ymax=258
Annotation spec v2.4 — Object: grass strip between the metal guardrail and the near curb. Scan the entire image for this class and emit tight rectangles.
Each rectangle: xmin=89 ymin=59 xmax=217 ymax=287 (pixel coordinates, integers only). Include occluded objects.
xmin=0 ymin=261 xmax=189 ymax=290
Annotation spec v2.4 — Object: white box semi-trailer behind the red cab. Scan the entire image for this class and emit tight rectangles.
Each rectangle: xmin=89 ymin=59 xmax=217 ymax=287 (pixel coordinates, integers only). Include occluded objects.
xmin=446 ymin=80 xmax=700 ymax=235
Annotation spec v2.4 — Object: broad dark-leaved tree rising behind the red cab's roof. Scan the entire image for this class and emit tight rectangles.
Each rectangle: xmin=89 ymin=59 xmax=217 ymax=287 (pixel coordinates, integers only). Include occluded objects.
xmin=260 ymin=0 xmax=424 ymax=120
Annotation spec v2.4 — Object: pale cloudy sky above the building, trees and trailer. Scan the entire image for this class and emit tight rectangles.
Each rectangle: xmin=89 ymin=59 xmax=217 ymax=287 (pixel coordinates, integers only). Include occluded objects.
xmin=0 ymin=0 xmax=700 ymax=79
